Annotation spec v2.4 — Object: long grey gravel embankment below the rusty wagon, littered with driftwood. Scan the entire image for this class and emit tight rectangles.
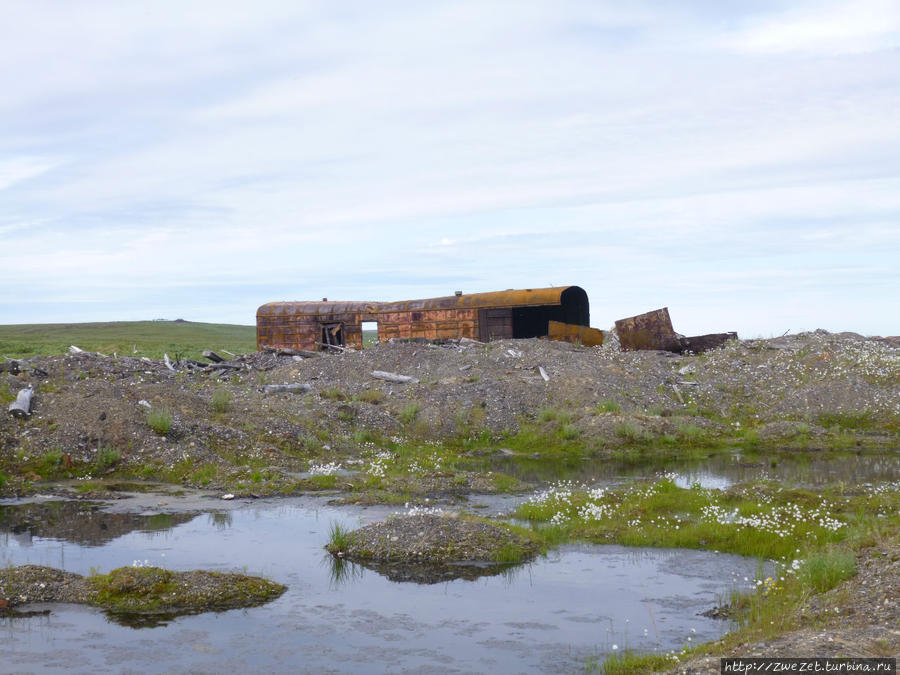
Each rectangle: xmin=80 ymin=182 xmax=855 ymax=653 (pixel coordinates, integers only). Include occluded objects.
xmin=0 ymin=331 xmax=900 ymax=491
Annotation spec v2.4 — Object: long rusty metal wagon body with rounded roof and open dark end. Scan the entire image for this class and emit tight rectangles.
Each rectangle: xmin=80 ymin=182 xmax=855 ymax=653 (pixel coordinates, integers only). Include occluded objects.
xmin=256 ymin=286 xmax=603 ymax=350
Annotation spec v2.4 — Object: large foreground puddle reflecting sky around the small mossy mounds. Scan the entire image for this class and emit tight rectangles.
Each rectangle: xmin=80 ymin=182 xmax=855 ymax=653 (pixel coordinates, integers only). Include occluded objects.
xmin=0 ymin=498 xmax=757 ymax=673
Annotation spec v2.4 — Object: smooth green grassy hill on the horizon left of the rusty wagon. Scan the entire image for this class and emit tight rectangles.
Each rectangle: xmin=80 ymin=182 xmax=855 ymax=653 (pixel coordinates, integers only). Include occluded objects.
xmin=0 ymin=321 xmax=256 ymax=359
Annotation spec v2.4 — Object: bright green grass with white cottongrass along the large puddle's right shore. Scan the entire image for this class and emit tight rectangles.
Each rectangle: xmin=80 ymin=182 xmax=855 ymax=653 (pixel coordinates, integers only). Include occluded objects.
xmin=514 ymin=477 xmax=900 ymax=673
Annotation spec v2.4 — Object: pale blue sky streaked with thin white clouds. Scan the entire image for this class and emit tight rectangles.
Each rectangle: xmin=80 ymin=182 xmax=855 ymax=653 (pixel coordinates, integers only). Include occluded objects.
xmin=0 ymin=0 xmax=900 ymax=337
